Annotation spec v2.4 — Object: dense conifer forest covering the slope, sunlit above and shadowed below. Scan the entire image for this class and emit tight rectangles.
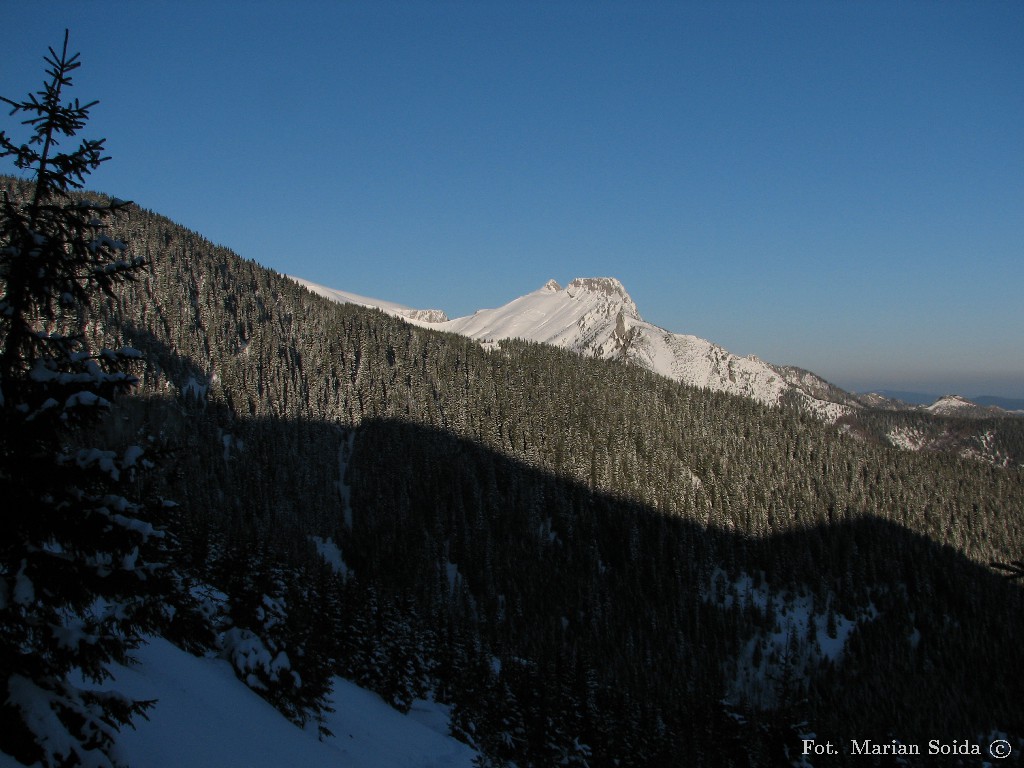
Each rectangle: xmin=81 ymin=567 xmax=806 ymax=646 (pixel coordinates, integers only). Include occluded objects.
xmin=0 ymin=34 xmax=1024 ymax=768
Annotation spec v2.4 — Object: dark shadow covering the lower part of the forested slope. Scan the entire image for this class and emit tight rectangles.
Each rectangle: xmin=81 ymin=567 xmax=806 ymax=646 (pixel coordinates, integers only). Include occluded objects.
xmin=125 ymin=378 xmax=1024 ymax=765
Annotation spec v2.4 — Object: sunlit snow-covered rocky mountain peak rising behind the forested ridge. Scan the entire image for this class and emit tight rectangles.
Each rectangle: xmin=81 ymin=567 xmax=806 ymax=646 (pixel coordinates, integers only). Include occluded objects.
xmin=299 ymin=278 xmax=860 ymax=420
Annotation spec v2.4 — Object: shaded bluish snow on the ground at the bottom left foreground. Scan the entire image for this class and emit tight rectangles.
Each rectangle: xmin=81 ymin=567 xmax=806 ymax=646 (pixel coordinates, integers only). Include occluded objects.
xmin=0 ymin=638 xmax=476 ymax=768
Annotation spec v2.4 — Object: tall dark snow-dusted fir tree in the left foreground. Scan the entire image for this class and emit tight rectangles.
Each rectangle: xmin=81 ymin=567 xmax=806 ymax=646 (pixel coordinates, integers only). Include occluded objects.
xmin=0 ymin=33 xmax=168 ymax=766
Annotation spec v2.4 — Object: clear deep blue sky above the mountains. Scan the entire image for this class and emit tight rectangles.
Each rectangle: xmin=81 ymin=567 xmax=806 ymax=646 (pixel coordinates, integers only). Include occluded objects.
xmin=0 ymin=6 xmax=1024 ymax=397
